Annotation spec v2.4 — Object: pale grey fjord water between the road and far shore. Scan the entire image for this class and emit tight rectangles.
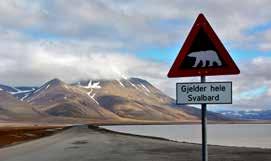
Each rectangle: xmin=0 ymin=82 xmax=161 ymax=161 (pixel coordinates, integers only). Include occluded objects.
xmin=103 ymin=124 xmax=271 ymax=148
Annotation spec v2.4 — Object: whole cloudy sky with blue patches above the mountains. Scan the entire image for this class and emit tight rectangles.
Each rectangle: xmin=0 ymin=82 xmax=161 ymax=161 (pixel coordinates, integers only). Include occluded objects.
xmin=0 ymin=0 xmax=271 ymax=110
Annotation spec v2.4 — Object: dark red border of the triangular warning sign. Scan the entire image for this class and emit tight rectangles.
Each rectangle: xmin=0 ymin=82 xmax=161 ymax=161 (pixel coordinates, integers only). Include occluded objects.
xmin=168 ymin=14 xmax=240 ymax=78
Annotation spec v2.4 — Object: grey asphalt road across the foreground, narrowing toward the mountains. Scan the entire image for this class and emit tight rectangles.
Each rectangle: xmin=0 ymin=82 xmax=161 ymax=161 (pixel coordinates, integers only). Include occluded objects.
xmin=0 ymin=126 xmax=271 ymax=161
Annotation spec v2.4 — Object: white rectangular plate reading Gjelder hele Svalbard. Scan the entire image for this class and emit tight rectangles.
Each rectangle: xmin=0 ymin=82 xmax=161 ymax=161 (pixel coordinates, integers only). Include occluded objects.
xmin=176 ymin=82 xmax=232 ymax=104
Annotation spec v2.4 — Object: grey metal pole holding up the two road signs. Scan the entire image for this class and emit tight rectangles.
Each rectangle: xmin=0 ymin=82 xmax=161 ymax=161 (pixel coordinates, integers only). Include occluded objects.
xmin=200 ymin=76 xmax=208 ymax=161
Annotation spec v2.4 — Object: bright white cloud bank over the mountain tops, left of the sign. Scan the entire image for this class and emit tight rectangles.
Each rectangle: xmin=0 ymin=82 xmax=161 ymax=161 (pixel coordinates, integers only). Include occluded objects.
xmin=0 ymin=29 xmax=167 ymax=85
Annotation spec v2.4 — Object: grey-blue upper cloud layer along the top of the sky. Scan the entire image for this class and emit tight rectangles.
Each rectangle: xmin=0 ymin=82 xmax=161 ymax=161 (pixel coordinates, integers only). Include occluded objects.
xmin=0 ymin=0 xmax=271 ymax=50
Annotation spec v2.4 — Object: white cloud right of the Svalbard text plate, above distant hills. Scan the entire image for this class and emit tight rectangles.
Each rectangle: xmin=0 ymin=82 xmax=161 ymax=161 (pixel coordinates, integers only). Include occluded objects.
xmin=214 ymin=57 xmax=271 ymax=109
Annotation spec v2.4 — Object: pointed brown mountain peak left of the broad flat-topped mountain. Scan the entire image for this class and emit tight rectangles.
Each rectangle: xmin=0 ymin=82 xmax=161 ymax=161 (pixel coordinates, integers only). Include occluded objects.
xmin=25 ymin=79 xmax=119 ymax=120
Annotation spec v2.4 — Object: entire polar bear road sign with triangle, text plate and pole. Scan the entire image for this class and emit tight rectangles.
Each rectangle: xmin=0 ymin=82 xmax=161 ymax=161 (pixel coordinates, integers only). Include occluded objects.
xmin=168 ymin=14 xmax=240 ymax=161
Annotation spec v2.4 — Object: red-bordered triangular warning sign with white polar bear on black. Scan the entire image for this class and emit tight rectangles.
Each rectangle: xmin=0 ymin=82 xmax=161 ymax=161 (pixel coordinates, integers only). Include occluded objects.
xmin=168 ymin=14 xmax=240 ymax=77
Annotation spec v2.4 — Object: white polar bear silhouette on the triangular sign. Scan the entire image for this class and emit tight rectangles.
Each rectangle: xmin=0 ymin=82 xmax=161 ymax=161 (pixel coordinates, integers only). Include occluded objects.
xmin=187 ymin=50 xmax=222 ymax=68
